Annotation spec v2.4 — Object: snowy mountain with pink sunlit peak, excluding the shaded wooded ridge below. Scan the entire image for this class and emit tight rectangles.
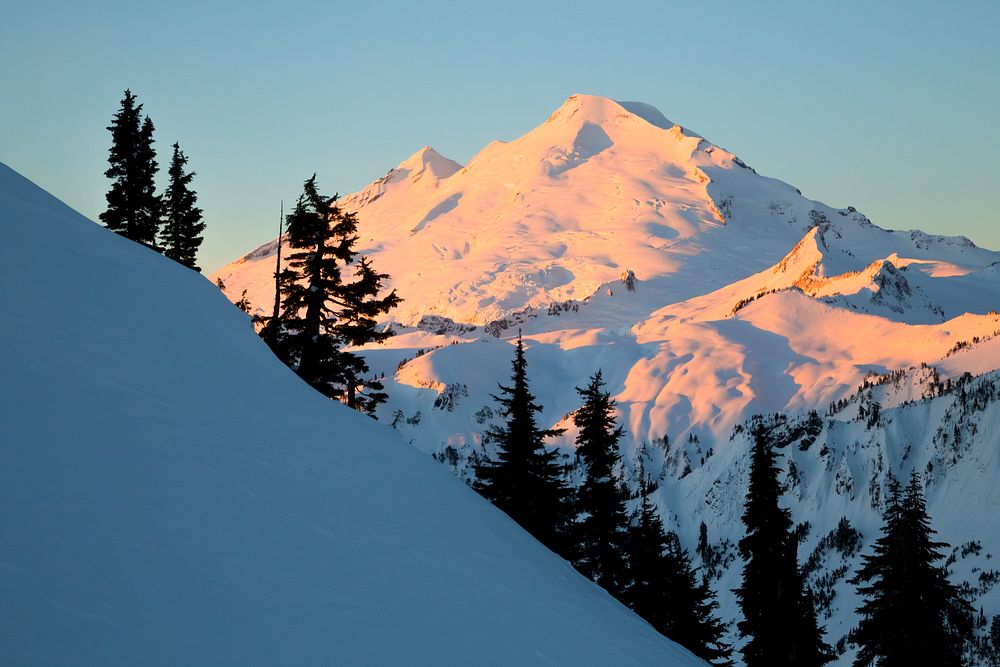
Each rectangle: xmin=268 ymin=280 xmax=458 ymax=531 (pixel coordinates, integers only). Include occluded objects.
xmin=215 ymin=95 xmax=1000 ymax=460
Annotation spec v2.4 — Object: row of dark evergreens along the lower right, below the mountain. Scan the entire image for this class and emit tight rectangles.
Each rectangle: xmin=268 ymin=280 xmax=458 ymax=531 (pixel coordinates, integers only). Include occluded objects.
xmin=473 ymin=336 xmax=972 ymax=667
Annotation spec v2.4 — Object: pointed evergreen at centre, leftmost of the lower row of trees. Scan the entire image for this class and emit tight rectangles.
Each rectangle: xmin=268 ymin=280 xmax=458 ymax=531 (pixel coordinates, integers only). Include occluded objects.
xmin=475 ymin=336 xmax=570 ymax=555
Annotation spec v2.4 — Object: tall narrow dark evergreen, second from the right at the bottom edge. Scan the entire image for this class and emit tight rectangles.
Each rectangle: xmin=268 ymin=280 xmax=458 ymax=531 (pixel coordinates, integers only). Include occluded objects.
xmin=735 ymin=425 xmax=833 ymax=667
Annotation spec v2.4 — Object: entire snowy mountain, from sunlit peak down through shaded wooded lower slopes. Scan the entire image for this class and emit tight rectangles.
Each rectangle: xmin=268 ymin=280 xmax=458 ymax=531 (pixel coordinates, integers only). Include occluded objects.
xmin=215 ymin=95 xmax=1000 ymax=661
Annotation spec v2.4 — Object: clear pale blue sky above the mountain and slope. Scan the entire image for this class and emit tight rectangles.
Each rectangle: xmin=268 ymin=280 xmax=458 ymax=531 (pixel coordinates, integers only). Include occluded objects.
xmin=0 ymin=0 xmax=1000 ymax=271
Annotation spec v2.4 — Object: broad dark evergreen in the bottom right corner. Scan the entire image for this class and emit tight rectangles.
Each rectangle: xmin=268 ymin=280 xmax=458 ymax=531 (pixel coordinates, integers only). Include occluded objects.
xmin=851 ymin=473 xmax=972 ymax=667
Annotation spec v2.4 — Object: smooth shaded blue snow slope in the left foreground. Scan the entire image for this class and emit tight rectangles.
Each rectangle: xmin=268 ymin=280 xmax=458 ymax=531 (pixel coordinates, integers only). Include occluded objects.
xmin=0 ymin=165 xmax=700 ymax=665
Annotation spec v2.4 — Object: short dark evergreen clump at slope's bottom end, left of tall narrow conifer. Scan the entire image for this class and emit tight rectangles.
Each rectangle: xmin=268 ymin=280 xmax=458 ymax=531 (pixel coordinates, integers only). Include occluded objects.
xmin=622 ymin=489 xmax=731 ymax=665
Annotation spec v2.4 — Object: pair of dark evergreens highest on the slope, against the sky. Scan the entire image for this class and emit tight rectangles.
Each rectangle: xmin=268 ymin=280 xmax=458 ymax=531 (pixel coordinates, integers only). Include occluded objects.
xmin=100 ymin=90 xmax=205 ymax=271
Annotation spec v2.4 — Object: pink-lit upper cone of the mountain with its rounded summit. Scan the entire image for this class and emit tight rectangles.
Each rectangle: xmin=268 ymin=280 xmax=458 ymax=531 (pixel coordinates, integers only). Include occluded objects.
xmin=215 ymin=95 xmax=989 ymax=325
